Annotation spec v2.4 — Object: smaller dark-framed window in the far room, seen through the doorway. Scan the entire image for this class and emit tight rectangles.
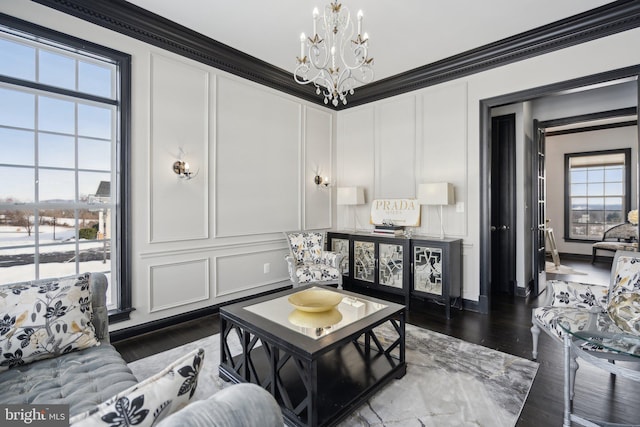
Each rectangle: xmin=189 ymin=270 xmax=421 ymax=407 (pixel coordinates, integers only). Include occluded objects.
xmin=565 ymin=149 xmax=631 ymax=241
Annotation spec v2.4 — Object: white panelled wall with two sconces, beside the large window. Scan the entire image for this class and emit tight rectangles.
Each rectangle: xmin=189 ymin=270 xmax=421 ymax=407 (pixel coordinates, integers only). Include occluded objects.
xmin=2 ymin=0 xmax=336 ymax=330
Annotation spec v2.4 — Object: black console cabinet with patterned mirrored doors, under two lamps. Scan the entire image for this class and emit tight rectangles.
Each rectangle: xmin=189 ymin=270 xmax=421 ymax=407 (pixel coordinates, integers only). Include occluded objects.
xmin=327 ymin=231 xmax=462 ymax=318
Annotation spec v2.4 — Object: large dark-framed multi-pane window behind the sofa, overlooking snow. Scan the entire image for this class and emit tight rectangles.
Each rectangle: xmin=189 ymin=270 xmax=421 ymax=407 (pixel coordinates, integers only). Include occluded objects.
xmin=0 ymin=15 xmax=131 ymax=320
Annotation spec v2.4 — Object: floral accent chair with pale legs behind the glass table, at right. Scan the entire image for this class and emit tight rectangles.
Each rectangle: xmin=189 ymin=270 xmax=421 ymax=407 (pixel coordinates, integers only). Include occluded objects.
xmin=531 ymin=251 xmax=640 ymax=395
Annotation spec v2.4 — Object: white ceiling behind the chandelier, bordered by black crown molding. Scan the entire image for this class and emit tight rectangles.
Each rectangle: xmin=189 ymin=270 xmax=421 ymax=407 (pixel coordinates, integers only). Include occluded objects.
xmin=128 ymin=0 xmax=612 ymax=80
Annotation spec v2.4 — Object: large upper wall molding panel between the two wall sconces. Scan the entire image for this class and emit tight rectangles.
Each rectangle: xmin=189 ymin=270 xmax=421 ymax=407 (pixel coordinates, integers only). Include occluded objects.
xmin=214 ymin=77 xmax=302 ymax=238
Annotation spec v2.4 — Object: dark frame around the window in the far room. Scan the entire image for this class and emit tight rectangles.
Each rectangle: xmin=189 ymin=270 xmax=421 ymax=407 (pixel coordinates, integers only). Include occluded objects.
xmin=564 ymin=148 xmax=632 ymax=244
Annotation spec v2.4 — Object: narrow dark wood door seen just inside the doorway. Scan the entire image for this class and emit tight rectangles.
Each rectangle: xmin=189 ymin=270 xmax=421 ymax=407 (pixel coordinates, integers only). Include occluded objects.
xmin=491 ymin=114 xmax=516 ymax=295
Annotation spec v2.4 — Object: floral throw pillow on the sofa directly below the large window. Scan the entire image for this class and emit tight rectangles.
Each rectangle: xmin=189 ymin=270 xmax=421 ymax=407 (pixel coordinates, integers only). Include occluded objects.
xmin=0 ymin=273 xmax=99 ymax=372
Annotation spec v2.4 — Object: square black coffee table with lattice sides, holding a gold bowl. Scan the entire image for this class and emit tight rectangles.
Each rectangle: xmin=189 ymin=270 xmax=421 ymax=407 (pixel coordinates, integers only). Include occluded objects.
xmin=219 ymin=285 xmax=407 ymax=427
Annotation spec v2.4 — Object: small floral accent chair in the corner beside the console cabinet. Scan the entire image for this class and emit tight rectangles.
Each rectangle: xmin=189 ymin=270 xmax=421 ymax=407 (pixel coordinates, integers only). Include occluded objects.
xmin=285 ymin=231 xmax=342 ymax=289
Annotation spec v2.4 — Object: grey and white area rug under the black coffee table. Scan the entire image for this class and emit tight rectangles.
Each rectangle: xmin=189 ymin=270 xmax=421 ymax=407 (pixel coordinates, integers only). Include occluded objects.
xmin=129 ymin=325 xmax=538 ymax=427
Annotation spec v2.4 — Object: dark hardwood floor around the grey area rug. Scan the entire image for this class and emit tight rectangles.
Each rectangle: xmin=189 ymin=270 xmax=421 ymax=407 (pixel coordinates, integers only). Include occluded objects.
xmin=114 ymin=259 xmax=640 ymax=427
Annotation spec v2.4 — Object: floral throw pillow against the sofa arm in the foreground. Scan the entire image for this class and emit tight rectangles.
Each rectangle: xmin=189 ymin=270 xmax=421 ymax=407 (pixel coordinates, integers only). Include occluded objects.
xmin=69 ymin=348 xmax=204 ymax=427
